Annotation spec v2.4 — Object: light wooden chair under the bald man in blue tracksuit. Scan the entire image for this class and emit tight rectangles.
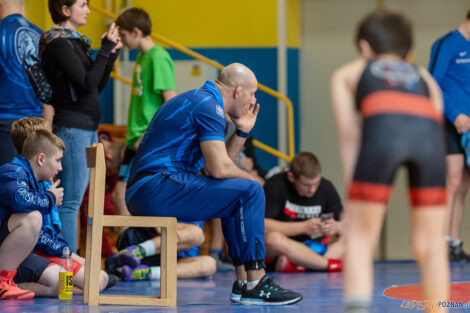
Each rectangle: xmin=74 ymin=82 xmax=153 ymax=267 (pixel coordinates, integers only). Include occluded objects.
xmin=83 ymin=143 xmax=176 ymax=306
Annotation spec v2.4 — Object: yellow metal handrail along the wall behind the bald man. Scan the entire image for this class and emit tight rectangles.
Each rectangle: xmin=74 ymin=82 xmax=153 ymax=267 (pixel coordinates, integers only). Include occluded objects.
xmin=88 ymin=3 xmax=295 ymax=162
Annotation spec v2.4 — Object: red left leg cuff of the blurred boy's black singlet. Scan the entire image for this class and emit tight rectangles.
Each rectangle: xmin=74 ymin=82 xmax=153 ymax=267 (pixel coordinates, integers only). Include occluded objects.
xmin=348 ymin=181 xmax=392 ymax=203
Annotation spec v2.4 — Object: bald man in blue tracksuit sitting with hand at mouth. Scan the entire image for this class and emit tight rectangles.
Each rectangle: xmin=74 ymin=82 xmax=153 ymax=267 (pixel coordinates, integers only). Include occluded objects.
xmin=126 ymin=63 xmax=302 ymax=305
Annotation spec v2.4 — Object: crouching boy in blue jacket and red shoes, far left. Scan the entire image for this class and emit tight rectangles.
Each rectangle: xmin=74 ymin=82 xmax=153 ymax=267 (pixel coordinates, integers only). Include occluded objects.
xmin=0 ymin=130 xmax=65 ymax=299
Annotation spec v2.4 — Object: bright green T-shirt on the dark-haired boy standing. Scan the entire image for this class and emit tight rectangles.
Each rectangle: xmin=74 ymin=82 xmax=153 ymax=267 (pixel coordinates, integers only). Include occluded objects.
xmin=126 ymin=45 xmax=176 ymax=149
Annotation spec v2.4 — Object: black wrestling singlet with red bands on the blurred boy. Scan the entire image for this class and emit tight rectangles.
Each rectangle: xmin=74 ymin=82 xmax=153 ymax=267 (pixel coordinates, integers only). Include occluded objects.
xmin=349 ymin=59 xmax=446 ymax=207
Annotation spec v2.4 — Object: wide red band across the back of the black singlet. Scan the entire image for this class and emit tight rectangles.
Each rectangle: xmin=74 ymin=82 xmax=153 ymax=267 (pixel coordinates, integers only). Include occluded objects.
xmin=361 ymin=91 xmax=442 ymax=122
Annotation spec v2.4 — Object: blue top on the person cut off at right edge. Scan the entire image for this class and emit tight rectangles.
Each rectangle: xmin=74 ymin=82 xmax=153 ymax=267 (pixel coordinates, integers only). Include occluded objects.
xmin=429 ymin=29 xmax=470 ymax=123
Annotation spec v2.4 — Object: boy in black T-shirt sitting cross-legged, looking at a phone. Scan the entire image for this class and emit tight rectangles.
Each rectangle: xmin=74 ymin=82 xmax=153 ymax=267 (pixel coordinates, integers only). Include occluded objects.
xmin=264 ymin=152 xmax=344 ymax=272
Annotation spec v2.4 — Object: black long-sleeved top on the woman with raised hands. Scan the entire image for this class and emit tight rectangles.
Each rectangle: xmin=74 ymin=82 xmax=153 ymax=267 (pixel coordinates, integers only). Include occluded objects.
xmin=42 ymin=38 xmax=118 ymax=130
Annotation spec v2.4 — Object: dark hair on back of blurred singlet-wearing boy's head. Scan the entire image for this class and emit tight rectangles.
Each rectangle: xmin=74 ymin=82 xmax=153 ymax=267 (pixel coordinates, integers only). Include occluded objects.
xmin=356 ymin=9 xmax=413 ymax=59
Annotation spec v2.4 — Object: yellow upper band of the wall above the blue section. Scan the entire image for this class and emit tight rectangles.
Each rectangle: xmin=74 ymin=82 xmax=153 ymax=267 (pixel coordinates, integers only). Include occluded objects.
xmin=25 ymin=0 xmax=300 ymax=48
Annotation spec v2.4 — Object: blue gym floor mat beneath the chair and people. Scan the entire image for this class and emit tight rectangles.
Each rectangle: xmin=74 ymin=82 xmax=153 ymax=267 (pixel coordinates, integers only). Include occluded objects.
xmin=4 ymin=261 xmax=470 ymax=313
